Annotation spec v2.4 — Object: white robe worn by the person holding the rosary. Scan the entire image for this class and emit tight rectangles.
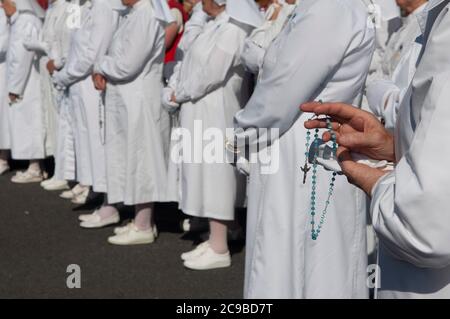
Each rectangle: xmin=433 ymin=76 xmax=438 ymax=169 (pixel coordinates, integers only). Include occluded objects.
xmin=371 ymin=0 xmax=450 ymax=299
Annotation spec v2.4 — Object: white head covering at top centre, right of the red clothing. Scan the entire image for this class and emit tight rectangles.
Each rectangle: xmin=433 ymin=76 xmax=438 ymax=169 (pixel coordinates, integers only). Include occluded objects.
xmin=225 ymin=0 xmax=264 ymax=27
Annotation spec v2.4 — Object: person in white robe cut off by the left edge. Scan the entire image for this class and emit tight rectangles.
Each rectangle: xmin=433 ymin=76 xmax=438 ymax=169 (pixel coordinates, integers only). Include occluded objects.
xmin=0 ymin=9 xmax=11 ymax=175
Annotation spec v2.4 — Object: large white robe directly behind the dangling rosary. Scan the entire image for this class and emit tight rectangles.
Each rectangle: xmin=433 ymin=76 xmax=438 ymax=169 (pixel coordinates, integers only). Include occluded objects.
xmin=235 ymin=0 xmax=374 ymax=298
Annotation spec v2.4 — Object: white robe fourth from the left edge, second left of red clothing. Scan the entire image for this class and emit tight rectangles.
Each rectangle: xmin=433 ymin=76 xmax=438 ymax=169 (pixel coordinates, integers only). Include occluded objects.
xmin=53 ymin=0 xmax=119 ymax=193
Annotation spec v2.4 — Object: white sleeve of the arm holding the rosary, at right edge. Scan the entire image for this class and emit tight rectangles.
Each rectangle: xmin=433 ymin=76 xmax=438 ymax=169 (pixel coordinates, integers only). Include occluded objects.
xmin=371 ymin=74 xmax=450 ymax=268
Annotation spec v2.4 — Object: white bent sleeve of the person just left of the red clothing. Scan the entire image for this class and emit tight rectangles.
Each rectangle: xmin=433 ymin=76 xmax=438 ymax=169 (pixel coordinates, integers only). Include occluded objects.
xmin=95 ymin=15 xmax=161 ymax=82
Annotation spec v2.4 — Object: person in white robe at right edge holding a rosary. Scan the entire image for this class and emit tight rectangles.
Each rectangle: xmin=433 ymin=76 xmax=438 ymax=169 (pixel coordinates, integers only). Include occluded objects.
xmin=302 ymin=0 xmax=450 ymax=299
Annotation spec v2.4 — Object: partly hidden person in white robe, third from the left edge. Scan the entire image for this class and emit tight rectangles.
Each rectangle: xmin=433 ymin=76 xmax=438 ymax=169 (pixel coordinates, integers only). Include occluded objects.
xmin=25 ymin=0 xmax=73 ymax=191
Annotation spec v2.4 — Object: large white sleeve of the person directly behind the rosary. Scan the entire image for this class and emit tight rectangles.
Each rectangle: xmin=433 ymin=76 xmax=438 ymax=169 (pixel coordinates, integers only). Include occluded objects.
xmin=235 ymin=0 xmax=354 ymax=144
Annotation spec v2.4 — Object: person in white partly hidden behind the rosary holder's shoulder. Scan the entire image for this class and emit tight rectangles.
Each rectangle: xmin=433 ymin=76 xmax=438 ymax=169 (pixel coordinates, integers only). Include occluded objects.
xmin=366 ymin=0 xmax=427 ymax=130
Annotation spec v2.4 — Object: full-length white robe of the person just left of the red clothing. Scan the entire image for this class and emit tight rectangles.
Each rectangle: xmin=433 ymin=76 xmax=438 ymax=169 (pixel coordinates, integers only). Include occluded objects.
xmin=95 ymin=0 xmax=167 ymax=205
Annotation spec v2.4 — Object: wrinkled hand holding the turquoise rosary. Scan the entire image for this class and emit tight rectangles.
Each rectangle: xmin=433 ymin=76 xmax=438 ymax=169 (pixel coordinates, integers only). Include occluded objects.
xmin=300 ymin=103 xmax=395 ymax=196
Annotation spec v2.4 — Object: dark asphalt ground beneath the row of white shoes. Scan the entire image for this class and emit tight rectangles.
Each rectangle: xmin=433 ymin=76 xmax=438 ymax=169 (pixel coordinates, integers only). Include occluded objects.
xmin=0 ymin=163 xmax=244 ymax=299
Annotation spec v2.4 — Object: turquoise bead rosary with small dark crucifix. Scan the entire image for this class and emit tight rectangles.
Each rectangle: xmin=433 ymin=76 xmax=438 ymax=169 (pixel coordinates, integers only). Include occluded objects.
xmin=301 ymin=118 xmax=337 ymax=240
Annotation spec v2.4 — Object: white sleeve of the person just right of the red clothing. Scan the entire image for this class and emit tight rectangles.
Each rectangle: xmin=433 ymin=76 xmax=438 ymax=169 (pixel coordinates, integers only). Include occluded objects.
xmin=175 ymin=23 xmax=245 ymax=103
